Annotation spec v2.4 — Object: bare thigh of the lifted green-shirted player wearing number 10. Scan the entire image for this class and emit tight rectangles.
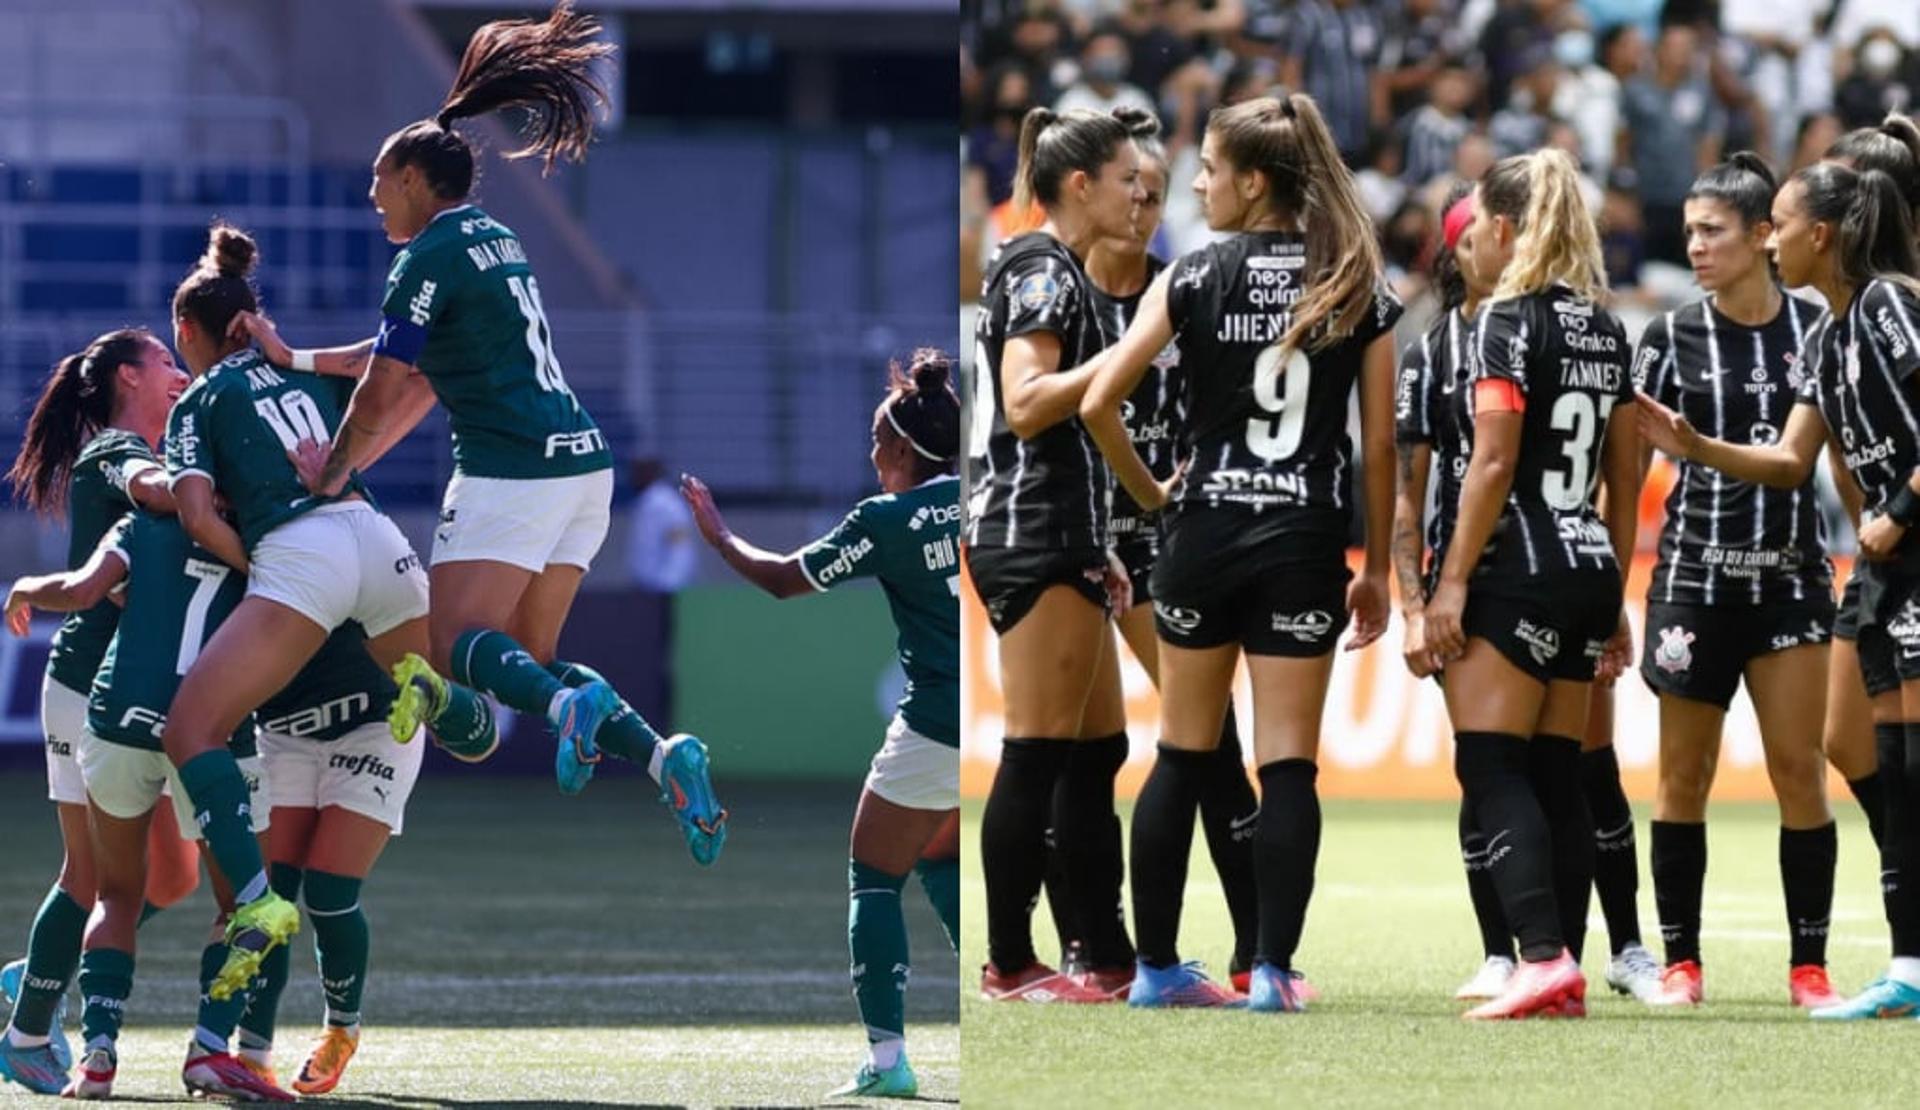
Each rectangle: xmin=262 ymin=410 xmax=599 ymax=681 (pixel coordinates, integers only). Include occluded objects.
xmin=163 ymin=597 xmax=330 ymax=764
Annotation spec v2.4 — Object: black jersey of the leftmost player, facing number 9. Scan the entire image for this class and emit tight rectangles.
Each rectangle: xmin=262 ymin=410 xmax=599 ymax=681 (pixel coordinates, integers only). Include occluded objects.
xmin=968 ymin=230 xmax=1108 ymax=549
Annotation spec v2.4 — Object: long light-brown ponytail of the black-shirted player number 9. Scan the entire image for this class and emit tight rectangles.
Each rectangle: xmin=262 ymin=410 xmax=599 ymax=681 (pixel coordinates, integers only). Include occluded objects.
xmin=1206 ymin=92 xmax=1382 ymax=350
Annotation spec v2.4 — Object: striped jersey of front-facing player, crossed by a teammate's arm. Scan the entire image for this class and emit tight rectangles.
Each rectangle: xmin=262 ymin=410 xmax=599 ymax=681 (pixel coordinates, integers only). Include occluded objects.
xmin=1634 ymin=296 xmax=1834 ymax=605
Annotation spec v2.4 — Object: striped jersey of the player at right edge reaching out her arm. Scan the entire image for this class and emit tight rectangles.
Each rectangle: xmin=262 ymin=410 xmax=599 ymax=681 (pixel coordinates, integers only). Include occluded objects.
xmin=1799 ymin=278 xmax=1920 ymax=526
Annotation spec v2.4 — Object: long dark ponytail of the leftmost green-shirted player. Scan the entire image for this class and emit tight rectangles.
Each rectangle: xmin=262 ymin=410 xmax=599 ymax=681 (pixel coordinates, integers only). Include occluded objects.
xmin=6 ymin=328 xmax=156 ymax=517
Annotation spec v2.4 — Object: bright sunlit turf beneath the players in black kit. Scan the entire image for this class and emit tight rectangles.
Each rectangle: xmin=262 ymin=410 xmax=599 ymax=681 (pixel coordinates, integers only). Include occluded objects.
xmin=962 ymin=799 xmax=1920 ymax=1110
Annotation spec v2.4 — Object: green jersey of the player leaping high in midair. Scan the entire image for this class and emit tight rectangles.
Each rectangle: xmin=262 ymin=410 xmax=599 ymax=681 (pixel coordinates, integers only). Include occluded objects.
xmin=374 ymin=205 xmax=612 ymax=478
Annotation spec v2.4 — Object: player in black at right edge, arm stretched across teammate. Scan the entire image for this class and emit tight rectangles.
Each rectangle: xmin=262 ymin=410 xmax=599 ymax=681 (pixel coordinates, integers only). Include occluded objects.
xmin=1640 ymin=161 xmax=1920 ymax=1020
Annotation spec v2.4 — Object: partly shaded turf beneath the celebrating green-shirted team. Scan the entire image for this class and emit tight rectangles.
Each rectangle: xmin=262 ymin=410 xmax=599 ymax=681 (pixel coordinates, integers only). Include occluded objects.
xmin=0 ymin=772 xmax=960 ymax=1106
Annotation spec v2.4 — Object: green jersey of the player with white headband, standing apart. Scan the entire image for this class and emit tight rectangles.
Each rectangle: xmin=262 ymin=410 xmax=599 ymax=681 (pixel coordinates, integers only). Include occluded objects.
xmin=801 ymin=474 xmax=960 ymax=747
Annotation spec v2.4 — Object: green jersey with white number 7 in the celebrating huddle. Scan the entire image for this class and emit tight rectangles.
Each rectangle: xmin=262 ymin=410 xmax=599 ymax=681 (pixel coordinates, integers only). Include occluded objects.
xmin=86 ymin=513 xmax=253 ymax=755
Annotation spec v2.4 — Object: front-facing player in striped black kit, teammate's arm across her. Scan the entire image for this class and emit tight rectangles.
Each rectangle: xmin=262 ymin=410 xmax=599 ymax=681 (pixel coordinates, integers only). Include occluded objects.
xmin=1634 ymin=152 xmax=1839 ymax=1008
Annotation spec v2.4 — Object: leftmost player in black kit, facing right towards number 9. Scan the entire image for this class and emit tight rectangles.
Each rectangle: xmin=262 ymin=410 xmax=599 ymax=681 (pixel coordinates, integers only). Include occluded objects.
xmin=966 ymin=108 xmax=1144 ymax=1002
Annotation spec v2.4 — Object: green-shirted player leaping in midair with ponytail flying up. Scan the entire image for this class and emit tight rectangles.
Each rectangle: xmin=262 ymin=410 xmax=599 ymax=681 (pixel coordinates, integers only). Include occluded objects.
xmin=246 ymin=0 xmax=726 ymax=844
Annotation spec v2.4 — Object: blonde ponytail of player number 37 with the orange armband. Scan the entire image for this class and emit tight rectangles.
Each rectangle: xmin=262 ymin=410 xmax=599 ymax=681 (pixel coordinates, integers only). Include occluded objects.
xmin=1480 ymin=148 xmax=1607 ymax=302
